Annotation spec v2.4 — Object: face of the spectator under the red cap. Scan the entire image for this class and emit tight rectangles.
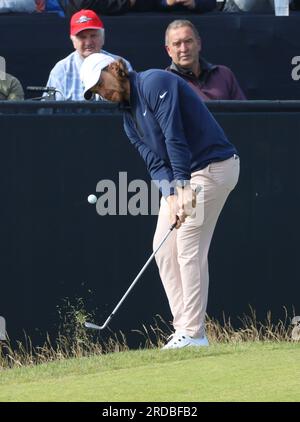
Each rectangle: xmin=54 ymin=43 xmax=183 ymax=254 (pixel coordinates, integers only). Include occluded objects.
xmin=71 ymin=29 xmax=103 ymax=59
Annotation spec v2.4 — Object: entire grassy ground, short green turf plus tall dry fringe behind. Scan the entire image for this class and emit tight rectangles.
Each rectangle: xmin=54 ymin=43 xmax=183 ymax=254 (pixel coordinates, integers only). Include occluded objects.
xmin=0 ymin=308 xmax=300 ymax=402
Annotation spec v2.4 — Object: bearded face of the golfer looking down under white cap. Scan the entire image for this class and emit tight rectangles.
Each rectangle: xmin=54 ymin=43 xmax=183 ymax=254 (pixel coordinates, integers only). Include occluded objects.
xmin=91 ymin=70 xmax=124 ymax=103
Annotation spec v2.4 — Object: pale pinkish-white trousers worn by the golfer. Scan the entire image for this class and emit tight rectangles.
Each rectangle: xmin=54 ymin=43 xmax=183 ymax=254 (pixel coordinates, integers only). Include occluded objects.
xmin=153 ymin=155 xmax=240 ymax=337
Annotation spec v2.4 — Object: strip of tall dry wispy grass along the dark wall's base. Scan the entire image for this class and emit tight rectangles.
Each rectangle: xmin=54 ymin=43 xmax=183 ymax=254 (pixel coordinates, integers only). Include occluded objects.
xmin=0 ymin=300 xmax=293 ymax=371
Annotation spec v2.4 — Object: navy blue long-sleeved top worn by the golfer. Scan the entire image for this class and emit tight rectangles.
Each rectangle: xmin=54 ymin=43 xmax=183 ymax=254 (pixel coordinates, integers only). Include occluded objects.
xmin=124 ymin=69 xmax=236 ymax=196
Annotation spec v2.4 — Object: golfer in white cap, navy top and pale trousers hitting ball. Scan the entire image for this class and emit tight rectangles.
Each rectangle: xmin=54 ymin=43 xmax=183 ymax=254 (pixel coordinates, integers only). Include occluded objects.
xmin=81 ymin=53 xmax=239 ymax=349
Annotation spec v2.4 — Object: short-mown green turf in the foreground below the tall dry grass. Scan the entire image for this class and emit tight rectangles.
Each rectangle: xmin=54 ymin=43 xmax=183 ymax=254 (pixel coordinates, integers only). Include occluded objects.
xmin=0 ymin=342 xmax=300 ymax=402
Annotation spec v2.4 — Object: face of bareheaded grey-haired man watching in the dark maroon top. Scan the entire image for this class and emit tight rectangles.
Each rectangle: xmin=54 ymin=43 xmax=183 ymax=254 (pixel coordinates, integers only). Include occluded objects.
xmin=166 ymin=26 xmax=201 ymax=68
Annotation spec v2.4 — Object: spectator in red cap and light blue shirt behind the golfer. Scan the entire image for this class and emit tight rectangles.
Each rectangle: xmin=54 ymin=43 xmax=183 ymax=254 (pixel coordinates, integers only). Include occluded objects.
xmin=47 ymin=10 xmax=132 ymax=101
